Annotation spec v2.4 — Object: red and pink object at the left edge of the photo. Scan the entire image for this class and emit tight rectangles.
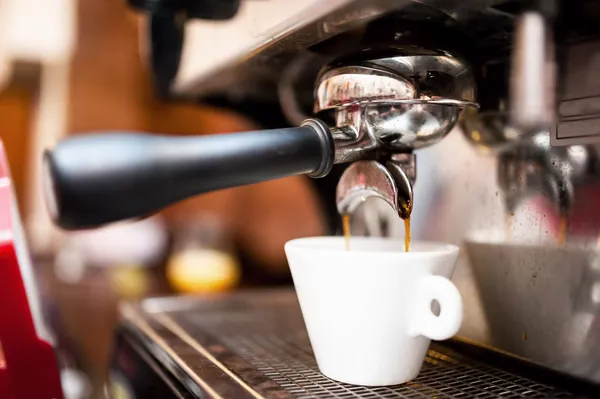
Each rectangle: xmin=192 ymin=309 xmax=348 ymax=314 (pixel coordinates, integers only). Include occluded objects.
xmin=0 ymin=142 xmax=63 ymax=399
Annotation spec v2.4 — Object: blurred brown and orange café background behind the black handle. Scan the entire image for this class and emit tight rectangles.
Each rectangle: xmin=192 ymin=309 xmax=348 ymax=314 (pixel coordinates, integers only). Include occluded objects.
xmin=0 ymin=0 xmax=337 ymax=398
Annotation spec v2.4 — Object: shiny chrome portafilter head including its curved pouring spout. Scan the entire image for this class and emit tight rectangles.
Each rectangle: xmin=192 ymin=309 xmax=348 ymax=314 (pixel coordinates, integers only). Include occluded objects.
xmin=324 ymin=47 xmax=478 ymax=222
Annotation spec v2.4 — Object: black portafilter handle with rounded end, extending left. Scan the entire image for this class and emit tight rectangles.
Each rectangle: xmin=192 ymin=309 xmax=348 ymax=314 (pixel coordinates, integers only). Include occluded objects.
xmin=44 ymin=119 xmax=334 ymax=230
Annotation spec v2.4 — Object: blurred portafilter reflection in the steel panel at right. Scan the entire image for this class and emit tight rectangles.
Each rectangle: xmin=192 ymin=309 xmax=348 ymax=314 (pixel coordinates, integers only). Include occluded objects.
xmin=461 ymin=113 xmax=600 ymax=217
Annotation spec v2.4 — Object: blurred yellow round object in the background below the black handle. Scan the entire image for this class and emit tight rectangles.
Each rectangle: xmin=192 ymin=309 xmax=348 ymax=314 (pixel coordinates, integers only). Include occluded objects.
xmin=167 ymin=249 xmax=240 ymax=293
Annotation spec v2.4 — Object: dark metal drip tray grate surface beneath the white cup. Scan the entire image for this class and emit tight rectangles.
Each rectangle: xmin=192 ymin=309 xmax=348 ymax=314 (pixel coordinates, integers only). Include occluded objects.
xmin=141 ymin=290 xmax=573 ymax=399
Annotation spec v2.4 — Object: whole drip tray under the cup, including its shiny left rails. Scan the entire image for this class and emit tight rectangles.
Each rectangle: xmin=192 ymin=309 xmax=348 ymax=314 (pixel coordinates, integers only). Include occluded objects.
xmin=117 ymin=290 xmax=596 ymax=398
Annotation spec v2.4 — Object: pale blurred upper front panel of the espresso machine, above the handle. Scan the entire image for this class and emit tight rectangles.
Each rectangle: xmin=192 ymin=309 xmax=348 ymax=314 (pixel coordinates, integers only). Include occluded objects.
xmin=171 ymin=0 xmax=410 ymax=98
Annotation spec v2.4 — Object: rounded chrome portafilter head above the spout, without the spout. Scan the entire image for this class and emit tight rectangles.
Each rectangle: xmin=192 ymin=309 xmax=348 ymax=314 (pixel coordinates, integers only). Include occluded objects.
xmin=315 ymin=47 xmax=478 ymax=158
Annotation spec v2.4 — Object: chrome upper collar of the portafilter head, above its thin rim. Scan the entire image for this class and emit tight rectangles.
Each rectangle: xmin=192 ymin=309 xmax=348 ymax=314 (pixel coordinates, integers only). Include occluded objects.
xmin=315 ymin=51 xmax=477 ymax=113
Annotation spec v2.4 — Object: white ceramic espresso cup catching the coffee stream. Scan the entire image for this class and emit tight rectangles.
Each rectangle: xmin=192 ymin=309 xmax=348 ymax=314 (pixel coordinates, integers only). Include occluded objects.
xmin=285 ymin=237 xmax=463 ymax=386
